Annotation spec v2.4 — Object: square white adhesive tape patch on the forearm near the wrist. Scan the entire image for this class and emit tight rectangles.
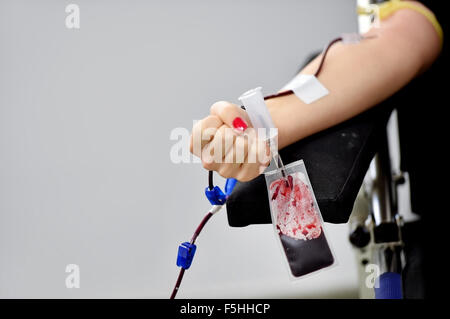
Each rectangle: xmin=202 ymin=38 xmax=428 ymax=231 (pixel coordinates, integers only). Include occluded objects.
xmin=281 ymin=74 xmax=330 ymax=104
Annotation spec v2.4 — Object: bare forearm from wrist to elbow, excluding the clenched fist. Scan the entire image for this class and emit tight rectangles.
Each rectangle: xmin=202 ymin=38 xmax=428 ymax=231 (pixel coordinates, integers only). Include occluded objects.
xmin=267 ymin=3 xmax=440 ymax=148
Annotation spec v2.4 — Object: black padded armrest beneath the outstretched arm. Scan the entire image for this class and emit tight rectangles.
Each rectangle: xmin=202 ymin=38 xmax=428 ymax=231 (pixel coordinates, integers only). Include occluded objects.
xmin=227 ymin=101 xmax=392 ymax=227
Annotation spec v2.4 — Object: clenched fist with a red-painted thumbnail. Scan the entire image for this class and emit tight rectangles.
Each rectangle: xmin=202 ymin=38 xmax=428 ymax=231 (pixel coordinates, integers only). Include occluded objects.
xmin=190 ymin=101 xmax=270 ymax=182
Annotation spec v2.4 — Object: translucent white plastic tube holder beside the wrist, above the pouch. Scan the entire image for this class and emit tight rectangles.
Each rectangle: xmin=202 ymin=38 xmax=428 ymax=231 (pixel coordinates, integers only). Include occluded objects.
xmin=239 ymin=87 xmax=287 ymax=180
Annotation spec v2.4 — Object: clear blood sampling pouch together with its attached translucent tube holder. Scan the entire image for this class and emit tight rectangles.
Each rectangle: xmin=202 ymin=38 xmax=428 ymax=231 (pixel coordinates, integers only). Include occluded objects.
xmin=239 ymin=88 xmax=334 ymax=277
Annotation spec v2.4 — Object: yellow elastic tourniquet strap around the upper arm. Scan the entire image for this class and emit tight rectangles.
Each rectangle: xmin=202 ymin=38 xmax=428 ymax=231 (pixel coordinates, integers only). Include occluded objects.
xmin=379 ymin=0 xmax=444 ymax=45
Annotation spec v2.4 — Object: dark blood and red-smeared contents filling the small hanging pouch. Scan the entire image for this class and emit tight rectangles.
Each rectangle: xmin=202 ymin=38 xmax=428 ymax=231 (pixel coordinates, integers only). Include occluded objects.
xmin=269 ymin=172 xmax=334 ymax=277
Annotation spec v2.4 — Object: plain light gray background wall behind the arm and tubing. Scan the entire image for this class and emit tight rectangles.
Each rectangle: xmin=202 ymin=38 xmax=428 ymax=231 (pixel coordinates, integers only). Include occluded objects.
xmin=0 ymin=0 xmax=357 ymax=298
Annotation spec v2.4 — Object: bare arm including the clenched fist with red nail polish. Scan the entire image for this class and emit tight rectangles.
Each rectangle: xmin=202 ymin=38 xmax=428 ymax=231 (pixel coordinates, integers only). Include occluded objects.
xmin=191 ymin=1 xmax=441 ymax=181
